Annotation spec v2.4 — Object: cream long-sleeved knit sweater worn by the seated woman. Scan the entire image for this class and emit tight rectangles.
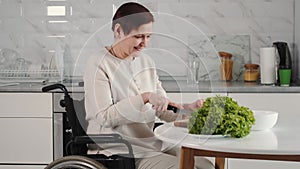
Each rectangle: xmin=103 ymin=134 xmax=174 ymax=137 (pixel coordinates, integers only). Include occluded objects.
xmin=84 ymin=49 xmax=177 ymax=153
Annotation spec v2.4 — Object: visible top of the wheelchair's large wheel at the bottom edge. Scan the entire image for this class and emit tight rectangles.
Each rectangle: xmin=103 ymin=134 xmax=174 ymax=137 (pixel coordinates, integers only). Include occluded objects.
xmin=45 ymin=155 xmax=106 ymax=169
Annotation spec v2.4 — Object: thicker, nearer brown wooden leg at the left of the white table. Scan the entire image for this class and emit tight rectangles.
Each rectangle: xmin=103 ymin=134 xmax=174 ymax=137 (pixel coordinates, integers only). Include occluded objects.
xmin=180 ymin=147 xmax=195 ymax=169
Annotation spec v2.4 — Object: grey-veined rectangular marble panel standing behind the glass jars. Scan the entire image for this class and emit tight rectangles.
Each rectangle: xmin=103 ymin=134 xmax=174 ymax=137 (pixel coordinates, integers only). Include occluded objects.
xmin=188 ymin=35 xmax=250 ymax=81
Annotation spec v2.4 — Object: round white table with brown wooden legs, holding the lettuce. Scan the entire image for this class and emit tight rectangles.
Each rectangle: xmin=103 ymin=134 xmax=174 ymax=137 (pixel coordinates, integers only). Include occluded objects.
xmin=155 ymin=112 xmax=300 ymax=169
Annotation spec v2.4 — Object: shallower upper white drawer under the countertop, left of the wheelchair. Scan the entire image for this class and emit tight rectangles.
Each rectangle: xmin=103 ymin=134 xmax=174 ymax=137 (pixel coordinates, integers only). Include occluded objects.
xmin=0 ymin=93 xmax=52 ymax=117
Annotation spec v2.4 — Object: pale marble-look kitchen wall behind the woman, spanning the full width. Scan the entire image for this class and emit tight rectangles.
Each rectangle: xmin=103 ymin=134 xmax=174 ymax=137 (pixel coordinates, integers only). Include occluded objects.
xmin=0 ymin=0 xmax=299 ymax=80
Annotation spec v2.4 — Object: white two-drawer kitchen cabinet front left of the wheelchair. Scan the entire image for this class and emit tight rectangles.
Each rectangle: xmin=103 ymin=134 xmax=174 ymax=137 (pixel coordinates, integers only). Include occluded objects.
xmin=0 ymin=92 xmax=53 ymax=169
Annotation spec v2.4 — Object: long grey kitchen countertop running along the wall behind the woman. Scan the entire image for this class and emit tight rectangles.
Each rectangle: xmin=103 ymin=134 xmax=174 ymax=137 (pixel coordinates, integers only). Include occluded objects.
xmin=0 ymin=80 xmax=300 ymax=93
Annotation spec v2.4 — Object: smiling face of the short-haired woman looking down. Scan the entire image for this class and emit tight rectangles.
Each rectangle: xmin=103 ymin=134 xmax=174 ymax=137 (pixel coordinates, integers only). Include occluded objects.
xmin=120 ymin=22 xmax=153 ymax=56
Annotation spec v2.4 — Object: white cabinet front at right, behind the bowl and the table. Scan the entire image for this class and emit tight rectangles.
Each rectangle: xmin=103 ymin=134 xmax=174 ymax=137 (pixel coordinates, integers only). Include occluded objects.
xmin=228 ymin=93 xmax=300 ymax=169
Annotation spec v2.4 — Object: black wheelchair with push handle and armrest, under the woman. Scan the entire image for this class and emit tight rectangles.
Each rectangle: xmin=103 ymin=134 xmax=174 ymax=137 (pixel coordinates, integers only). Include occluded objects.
xmin=42 ymin=84 xmax=135 ymax=169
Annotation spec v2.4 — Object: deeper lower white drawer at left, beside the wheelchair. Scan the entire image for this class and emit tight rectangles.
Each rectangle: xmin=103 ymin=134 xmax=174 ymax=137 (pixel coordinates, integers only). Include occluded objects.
xmin=0 ymin=118 xmax=53 ymax=165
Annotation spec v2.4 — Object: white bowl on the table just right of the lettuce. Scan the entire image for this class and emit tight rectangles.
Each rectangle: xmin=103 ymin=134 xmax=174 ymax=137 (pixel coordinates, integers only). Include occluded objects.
xmin=251 ymin=110 xmax=278 ymax=130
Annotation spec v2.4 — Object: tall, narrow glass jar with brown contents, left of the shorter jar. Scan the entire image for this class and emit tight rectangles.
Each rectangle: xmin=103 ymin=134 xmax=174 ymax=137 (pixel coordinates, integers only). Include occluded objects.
xmin=219 ymin=52 xmax=233 ymax=81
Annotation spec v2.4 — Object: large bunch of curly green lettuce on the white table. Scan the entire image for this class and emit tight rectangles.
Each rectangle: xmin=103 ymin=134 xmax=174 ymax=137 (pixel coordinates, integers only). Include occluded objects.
xmin=188 ymin=96 xmax=255 ymax=138
